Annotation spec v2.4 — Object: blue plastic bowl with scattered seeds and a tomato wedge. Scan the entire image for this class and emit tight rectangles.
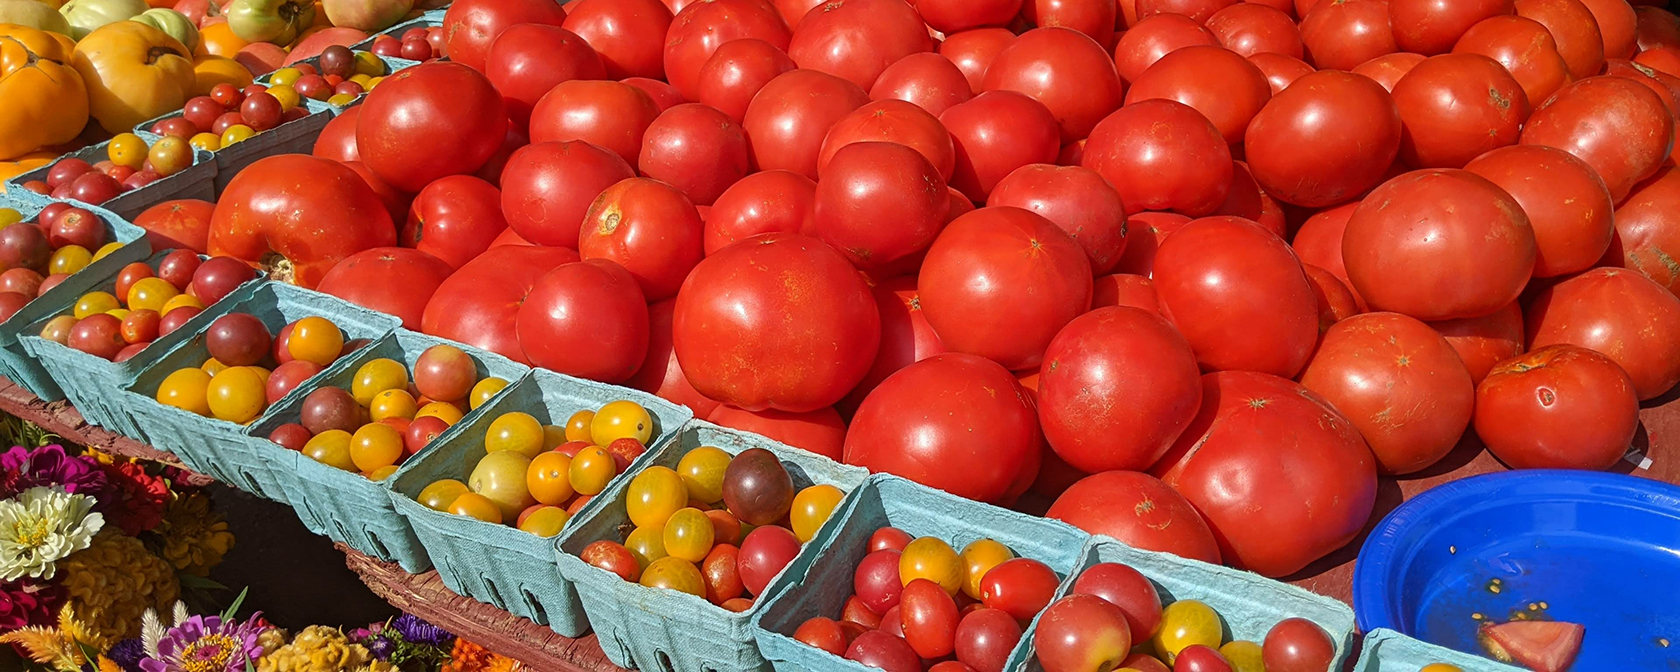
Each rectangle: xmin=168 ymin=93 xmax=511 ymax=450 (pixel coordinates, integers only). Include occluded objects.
xmin=1354 ymin=470 xmax=1680 ymax=672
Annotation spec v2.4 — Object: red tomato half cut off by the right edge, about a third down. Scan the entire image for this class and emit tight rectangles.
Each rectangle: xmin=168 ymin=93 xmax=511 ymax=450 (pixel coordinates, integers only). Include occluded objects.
xmin=1606 ymin=166 xmax=1680 ymax=292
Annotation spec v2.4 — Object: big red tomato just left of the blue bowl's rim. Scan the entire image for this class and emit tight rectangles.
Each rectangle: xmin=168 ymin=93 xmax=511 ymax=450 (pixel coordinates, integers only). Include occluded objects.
xmin=1152 ymin=371 xmax=1376 ymax=576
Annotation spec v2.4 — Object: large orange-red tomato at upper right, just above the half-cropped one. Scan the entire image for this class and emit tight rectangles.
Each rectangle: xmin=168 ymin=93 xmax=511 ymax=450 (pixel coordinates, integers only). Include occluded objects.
xmin=1522 ymin=77 xmax=1675 ymax=203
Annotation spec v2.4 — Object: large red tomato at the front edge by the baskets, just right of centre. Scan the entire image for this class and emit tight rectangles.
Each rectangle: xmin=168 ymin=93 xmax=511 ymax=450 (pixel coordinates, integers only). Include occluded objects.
xmin=845 ymin=353 xmax=1040 ymax=502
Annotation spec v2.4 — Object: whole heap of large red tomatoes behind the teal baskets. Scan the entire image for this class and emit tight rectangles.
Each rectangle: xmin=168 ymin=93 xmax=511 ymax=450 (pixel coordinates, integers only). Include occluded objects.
xmin=137 ymin=0 xmax=1680 ymax=576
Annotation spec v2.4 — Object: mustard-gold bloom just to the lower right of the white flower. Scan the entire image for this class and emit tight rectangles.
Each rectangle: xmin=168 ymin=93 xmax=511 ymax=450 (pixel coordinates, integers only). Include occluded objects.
xmin=64 ymin=528 xmax=181 ymax=648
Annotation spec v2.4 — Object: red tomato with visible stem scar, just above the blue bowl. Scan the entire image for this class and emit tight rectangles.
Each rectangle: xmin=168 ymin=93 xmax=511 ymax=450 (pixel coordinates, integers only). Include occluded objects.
xmin=1475 ymin=344 xmax=1640 ymax=469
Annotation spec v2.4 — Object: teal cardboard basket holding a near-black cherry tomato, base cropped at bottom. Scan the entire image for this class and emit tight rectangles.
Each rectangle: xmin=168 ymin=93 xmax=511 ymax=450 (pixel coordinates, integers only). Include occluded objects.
xmin=559 ymin=420 xmax=869 ymax=672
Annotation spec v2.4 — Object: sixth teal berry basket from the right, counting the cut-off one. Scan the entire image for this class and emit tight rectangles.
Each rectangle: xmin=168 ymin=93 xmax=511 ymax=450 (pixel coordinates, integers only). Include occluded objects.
xmin=247 ymin=329 xmax=531 ymax=573
